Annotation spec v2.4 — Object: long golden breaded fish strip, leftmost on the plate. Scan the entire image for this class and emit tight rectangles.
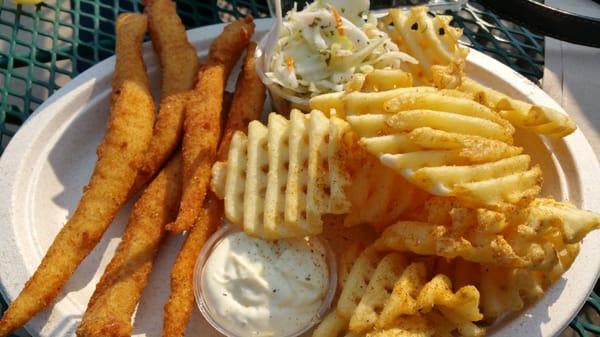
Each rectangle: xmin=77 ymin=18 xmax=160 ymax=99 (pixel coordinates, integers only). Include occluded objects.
xmin=0 ymin=14 xmax=154 ymax=337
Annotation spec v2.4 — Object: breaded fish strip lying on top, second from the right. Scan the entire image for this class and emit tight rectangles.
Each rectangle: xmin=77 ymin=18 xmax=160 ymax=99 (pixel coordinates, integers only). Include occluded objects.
xmin=167 ymin=18 xmax=254 ymax=234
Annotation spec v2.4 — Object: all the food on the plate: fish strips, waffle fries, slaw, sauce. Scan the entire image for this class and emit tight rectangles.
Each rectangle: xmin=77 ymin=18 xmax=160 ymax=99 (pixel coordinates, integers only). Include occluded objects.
xmin=0 ymin=0 xmax=600 ymax=337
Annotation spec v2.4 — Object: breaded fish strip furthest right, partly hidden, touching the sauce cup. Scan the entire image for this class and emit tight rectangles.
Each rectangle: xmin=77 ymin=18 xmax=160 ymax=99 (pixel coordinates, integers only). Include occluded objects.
xmin=163 ymin=43 xmax=265 ymax=337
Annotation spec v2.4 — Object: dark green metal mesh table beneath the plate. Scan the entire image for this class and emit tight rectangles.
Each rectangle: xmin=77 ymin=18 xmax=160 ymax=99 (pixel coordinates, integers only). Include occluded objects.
xmin=0 ymin=0 xmax=600 ymax=337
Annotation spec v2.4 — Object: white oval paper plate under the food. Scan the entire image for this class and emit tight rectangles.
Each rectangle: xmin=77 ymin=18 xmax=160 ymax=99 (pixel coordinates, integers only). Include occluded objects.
xmin=0 ymin=20 xmax=600 ymax=337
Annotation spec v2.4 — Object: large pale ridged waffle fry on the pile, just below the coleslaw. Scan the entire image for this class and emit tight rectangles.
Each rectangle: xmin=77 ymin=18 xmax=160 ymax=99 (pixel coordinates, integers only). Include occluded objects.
xmin=340 ymin=89 xmax=542 ymax=207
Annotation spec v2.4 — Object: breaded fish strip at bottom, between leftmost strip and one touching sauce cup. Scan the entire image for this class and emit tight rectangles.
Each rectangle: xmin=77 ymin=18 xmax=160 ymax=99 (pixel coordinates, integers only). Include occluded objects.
xmin=77 ymin=153 xmax=182 ymax=337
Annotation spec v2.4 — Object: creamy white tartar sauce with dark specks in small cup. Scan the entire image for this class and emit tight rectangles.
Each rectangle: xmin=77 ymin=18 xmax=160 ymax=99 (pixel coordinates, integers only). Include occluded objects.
xmin=201 ymin=232 xmax=329 ymax=337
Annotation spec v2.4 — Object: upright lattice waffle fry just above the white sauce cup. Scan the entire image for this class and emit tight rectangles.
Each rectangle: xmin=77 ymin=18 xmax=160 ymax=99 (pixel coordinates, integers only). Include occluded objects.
xmin=211 ymin=110 xmax=352 ymax=239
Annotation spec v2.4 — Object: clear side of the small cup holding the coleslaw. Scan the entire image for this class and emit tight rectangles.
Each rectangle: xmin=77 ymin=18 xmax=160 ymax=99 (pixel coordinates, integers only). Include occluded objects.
xmin=255 ymin=36 xmax=310 ymax=116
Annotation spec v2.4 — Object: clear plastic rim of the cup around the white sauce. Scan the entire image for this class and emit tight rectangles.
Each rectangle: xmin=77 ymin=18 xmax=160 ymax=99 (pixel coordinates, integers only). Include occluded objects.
xmin=193 ymin=223 xmax=337 ymax=337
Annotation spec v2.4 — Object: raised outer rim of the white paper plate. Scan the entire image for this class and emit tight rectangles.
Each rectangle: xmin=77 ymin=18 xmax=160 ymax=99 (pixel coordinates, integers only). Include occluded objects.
xmin=0 ymin=18 xmax=600 ymax=336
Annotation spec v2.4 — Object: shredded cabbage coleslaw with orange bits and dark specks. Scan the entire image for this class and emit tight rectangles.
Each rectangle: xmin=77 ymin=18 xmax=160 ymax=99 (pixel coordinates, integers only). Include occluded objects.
xmin=266 ymin=0 xmax=417 ymax=97
